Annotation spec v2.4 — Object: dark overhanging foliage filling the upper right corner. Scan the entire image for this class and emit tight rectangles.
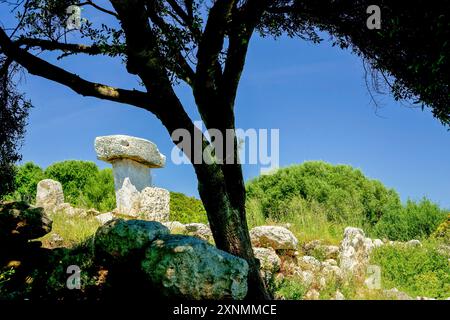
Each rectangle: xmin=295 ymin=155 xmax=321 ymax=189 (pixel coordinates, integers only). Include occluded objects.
xmin=259 ymin=0 xmax=450 ymax=126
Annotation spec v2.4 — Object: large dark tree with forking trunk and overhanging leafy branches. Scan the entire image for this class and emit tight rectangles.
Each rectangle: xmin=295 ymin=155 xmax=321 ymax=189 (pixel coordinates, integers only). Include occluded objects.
xmin=0 ymin=0 xmax=450 ymax=299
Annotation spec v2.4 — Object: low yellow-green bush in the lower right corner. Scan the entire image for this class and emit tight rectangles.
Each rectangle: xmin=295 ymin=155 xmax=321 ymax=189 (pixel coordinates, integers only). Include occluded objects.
xmin=372 ymin=243 xmax=450 ymax=299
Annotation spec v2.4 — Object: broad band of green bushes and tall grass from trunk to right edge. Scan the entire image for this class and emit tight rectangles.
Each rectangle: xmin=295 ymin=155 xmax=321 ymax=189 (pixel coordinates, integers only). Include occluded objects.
xmin=247 ymin=162 xmax=448 ymax=243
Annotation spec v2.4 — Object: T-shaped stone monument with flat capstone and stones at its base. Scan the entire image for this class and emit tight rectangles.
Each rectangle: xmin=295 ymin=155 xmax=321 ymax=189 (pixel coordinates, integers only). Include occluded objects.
xmin=95 ymin=135 xmax=170 ymax=221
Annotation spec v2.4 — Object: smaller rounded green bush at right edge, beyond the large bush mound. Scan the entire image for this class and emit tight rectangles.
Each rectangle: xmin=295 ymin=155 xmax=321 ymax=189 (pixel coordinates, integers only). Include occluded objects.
xmin=374 ymin=198 xmax=448 ymax=241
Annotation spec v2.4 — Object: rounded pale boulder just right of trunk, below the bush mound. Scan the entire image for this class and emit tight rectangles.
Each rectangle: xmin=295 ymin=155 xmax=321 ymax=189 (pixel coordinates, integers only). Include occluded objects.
xmin=250 ymin=226 xmax=298 ymax=250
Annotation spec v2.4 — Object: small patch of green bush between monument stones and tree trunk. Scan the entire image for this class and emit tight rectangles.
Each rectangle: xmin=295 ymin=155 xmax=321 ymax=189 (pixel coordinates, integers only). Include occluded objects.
xmin=170 ymin=192 xmax=208 ymax=223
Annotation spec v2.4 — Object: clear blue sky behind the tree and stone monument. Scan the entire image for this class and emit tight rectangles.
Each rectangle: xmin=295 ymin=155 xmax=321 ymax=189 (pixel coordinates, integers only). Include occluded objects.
xmin=5 ymin=23 xmax=450 ymax=208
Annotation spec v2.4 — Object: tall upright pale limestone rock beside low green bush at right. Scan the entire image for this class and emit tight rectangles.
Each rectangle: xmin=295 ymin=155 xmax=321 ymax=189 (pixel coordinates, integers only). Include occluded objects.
xmin=340 ymin=227 xmax=374 ymax=276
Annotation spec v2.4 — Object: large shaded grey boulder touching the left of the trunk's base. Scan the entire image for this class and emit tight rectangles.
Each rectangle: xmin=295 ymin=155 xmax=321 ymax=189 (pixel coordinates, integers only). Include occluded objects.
xmin=142 ymin=235 xmax=248 ymax=300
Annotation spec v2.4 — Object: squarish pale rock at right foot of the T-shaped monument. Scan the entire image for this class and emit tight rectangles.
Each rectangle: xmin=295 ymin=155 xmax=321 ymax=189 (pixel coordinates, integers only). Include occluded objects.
xmin=139 ymin=187 xmax=170 ymax=222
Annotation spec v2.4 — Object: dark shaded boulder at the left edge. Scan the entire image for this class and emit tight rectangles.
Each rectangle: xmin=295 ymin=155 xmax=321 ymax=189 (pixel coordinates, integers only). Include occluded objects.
xmin=0 ymin=201 xmax=52 ymax=247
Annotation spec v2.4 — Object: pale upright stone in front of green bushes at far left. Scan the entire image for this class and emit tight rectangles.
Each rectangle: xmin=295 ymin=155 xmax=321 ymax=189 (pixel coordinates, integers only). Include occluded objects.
xmin=36 ymin=179 xmax=64 ymax=213
